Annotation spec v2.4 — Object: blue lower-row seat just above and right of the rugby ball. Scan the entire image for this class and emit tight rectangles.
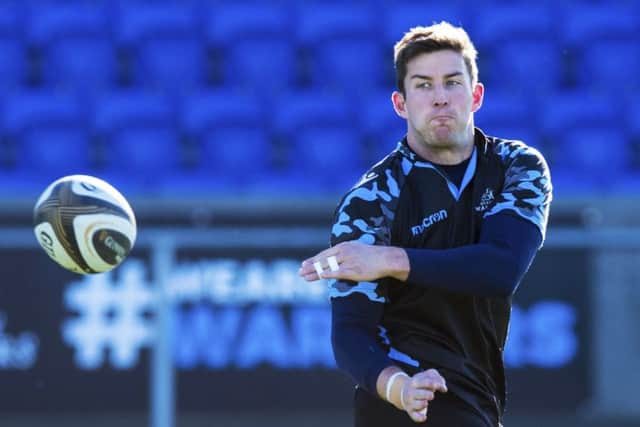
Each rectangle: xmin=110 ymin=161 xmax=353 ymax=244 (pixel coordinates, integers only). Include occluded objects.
xmin=93 ymin=91 xmax=183 ymax=191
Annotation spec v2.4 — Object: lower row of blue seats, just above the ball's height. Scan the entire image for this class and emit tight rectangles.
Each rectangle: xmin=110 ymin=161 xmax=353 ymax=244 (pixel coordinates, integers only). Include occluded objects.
xmin=0 ymin=91 xmax=640 ymax=198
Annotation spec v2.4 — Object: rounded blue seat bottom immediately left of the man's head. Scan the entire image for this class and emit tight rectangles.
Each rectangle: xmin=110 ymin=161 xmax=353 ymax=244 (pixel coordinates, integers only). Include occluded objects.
xmin=310 ymin=39 xmax=384 ymax=92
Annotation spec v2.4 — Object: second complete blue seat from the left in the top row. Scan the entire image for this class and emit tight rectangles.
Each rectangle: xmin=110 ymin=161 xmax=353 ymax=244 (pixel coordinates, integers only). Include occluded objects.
xmin=116 ymin=2 xmax=208 ymax=93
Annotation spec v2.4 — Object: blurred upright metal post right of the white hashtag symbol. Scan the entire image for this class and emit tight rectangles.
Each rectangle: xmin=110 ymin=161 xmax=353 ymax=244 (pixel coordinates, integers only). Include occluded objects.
xmin=150 ymin=233 xmax=175 ymax=427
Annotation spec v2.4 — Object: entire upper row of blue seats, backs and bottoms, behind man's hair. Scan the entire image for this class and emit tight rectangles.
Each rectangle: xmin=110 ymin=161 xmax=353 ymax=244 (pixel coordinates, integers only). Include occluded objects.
xmin=0 ymin=1 xmax=640 ymax=91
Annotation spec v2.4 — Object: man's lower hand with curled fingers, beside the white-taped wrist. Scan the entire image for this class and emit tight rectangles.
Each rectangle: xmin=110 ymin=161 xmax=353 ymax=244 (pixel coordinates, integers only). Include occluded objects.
xmin=401 ymin=369 xmax=447 ymax=423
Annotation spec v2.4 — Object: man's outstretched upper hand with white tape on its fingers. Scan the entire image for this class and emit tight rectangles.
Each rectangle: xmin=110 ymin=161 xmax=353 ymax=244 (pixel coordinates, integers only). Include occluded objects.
xmin=299 ymin=241 xmax=409 ymax=282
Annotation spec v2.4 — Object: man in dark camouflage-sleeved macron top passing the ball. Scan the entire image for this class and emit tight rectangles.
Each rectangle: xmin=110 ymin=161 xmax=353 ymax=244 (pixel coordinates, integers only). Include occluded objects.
xmin=300 ymin=22 xmax=551 ymax=427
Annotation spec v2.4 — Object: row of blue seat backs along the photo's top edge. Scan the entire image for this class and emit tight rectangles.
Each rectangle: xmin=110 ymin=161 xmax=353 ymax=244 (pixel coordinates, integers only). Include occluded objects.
xmin=5 ymin=0 xmax=640 ymax=47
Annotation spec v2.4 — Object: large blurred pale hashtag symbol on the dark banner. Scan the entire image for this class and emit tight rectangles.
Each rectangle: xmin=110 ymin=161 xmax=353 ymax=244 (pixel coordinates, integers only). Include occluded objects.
xmin=62 ymin=260 xmax=155 ymax=369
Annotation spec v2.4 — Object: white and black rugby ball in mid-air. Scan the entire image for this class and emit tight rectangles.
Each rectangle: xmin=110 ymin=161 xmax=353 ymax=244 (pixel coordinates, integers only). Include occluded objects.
xmin=33 ymin=175 xmax=137 ymax=274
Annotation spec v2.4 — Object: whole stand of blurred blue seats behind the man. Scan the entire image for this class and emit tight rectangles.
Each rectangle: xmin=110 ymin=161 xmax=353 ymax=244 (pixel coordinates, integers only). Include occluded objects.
xmin=0 ymin=0 xmax=640 ymax=194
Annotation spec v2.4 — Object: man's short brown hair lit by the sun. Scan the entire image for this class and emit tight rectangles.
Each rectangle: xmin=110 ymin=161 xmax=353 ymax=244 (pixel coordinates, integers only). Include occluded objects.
xmin=393 ymin=21 xmax=478 ymax=94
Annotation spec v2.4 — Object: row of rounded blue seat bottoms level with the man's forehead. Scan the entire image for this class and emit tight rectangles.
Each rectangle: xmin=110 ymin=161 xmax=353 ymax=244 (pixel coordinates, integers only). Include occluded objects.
xmin=0 ymin=39 xmax=640 ymax=93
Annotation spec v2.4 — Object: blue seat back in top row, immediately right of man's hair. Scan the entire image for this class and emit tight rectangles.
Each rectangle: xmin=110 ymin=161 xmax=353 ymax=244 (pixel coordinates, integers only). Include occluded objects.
xmin=470 ymin=3 xmax=556 ymax=48
